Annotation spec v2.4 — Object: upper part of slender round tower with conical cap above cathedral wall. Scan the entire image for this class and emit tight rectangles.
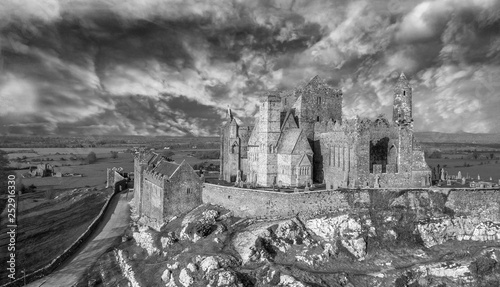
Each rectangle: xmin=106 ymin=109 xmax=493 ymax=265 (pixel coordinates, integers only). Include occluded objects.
xmin=392 ymin=73 xmax=413 ymax=125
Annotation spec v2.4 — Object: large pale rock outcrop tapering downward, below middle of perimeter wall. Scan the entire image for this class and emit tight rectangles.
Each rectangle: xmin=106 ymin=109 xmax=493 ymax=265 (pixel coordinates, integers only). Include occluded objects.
xmin=305 ymin=214 xmax=372 ymax=260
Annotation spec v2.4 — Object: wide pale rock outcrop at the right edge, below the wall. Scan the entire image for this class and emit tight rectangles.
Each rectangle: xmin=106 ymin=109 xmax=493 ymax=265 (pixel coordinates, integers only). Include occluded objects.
xmin=417 ymin=217 xmax=500 ymax=247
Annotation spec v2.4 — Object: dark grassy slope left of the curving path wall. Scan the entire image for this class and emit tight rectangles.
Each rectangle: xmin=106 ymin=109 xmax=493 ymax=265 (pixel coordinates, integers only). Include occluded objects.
xmin=0 ymin=189 xmax=111 ymax=284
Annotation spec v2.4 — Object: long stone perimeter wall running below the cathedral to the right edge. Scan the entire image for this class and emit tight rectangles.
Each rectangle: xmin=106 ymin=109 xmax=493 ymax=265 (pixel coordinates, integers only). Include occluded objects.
xmin=202 ymin=183 xmax=500 ymax=222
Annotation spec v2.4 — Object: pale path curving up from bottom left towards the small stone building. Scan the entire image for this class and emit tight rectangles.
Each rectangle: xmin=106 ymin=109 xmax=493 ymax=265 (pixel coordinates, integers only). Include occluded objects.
xmin=27 ymin=191 xmax=130 ymax=287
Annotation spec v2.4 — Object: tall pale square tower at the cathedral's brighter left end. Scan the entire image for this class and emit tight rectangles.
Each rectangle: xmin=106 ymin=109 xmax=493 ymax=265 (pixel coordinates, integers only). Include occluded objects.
xmin=252 ymin=95 xmax=281 ymax=186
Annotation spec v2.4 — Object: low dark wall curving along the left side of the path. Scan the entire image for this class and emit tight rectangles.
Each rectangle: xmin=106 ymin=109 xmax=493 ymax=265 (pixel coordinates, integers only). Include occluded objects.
xmin=1 ymin=192 xmax=119 ymax=287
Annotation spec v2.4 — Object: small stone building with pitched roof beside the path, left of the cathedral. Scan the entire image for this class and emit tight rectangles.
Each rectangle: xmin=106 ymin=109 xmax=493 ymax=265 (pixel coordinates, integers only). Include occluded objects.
xmin=134 ymin=151 xmax=203 ymax=230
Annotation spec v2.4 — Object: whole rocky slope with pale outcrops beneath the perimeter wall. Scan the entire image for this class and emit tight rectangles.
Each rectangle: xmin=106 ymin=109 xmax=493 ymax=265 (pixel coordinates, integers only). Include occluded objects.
xmin=113 ymin=195 xmax=500 ymax=287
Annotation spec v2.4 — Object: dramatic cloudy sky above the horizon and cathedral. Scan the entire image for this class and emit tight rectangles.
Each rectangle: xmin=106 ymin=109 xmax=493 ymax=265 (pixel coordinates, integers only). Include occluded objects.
xmin=0 ymin=0 xmax=500 ymax=136
